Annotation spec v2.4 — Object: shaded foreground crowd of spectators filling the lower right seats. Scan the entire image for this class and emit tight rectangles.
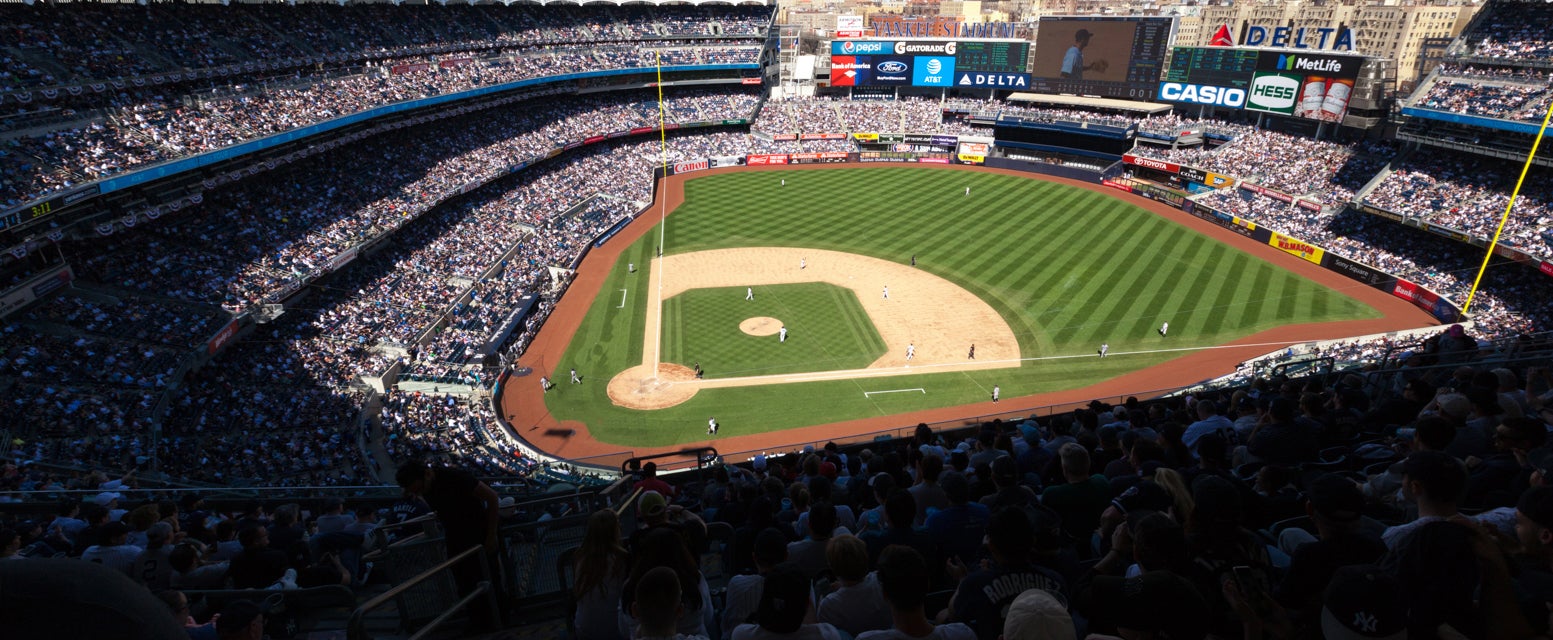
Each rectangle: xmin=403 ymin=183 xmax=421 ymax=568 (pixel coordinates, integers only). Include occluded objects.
xmin=555 ymin=352 xmax=1553 ymax=640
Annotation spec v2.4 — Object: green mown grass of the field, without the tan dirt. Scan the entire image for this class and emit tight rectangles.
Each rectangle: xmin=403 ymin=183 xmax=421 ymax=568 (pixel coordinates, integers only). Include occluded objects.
xmin=539 ymin=168 xmax=1381 ymax=450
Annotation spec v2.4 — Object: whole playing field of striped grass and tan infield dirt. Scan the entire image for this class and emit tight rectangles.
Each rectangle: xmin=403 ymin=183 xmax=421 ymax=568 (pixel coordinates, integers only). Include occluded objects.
xmin=519 ymin=168 xmax=1381 ymax=449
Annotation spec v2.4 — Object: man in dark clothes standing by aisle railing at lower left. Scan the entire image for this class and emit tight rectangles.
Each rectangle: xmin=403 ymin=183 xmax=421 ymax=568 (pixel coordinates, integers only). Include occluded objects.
xmin=394 ymin=461 xmax=502 ymax=629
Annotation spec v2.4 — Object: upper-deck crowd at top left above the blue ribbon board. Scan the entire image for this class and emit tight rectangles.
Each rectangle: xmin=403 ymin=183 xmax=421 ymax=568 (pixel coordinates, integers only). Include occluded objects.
xmin=0 ymin=6 xmax=763 ymax=207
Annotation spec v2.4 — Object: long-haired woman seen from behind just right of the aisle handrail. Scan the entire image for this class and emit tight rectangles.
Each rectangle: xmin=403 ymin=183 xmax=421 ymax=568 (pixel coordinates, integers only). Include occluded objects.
xmin=572 ymin=510 xmax=629 ymax=640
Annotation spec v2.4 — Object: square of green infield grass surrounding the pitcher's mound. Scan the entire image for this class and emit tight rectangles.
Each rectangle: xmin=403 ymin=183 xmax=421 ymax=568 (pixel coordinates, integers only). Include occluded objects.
xmin=663 ymin=283 xmax=885 ymax=377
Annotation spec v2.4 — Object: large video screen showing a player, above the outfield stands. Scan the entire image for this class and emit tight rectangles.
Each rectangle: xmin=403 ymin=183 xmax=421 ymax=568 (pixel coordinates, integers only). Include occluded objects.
xmin=1030 ymin=16 xmax=1174 ymax=99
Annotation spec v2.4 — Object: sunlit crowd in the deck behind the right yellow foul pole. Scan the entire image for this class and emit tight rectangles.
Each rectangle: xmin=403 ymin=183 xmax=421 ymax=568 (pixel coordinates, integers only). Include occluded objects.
xmin=1364 ymin=152 xmax=1553 ymax=259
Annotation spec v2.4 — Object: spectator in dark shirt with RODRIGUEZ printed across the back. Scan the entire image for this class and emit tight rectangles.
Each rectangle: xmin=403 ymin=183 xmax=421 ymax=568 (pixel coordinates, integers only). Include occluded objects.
xmin=940 ymin=508 xmax=1067 ymax=640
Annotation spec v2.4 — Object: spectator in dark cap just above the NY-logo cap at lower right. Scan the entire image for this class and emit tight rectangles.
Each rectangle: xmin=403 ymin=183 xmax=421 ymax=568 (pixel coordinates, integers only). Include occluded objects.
xmin=1273 ymin=474 xmax=1385 ymax=614
